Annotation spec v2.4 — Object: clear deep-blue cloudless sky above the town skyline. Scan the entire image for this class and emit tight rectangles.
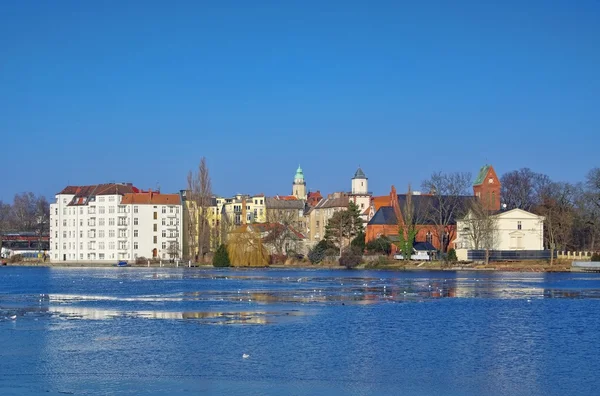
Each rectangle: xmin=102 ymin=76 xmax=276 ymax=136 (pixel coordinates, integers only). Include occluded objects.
xmin=0 ymin=0 xmax=600 ymax=200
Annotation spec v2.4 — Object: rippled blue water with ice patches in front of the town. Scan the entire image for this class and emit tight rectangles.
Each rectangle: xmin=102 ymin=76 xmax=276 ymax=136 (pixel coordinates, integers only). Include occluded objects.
xmin=0 ymin=267 xmax=600 ymax=395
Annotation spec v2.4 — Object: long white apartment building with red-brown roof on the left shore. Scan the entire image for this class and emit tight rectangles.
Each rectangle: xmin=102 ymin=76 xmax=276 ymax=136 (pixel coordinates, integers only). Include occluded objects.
xmin=50 ymin=183 xmax=183 ymax=262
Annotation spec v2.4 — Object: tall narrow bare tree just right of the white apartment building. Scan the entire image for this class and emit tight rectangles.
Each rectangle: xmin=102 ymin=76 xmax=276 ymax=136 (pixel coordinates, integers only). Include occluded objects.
xmin=186 ymin=157 xmax=212 ymax=260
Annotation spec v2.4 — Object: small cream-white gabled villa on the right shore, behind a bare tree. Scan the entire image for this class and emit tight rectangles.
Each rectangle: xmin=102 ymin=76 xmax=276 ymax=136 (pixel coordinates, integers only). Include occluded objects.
xmin=455 ymin=209 xmax=544 ymax=253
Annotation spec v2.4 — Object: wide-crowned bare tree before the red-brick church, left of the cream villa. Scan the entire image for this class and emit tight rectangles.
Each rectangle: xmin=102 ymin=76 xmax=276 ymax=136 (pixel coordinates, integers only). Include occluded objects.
xmin=422 ymin=172 xmax=473 ymax=252
